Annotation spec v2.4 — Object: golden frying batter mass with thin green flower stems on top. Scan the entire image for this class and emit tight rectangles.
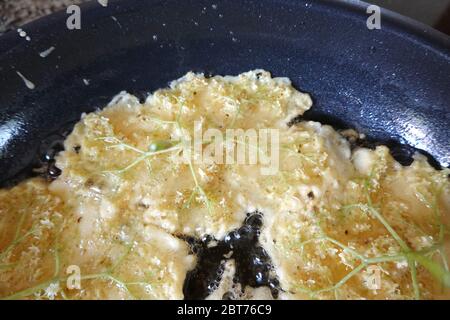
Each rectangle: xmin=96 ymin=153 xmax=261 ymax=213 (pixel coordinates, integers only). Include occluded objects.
xmin=0 ymin=70 xmax=450 ymax=299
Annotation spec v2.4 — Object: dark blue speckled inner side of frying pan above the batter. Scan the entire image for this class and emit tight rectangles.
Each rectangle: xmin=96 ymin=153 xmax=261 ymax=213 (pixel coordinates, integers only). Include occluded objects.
xmin=0 ymin=0 xmax=450 ymax=188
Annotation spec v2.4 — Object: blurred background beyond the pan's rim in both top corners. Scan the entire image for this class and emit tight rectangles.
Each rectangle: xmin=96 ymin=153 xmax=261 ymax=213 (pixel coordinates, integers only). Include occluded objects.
xmin=0 ymin=0 xmax=450 ymax=35
